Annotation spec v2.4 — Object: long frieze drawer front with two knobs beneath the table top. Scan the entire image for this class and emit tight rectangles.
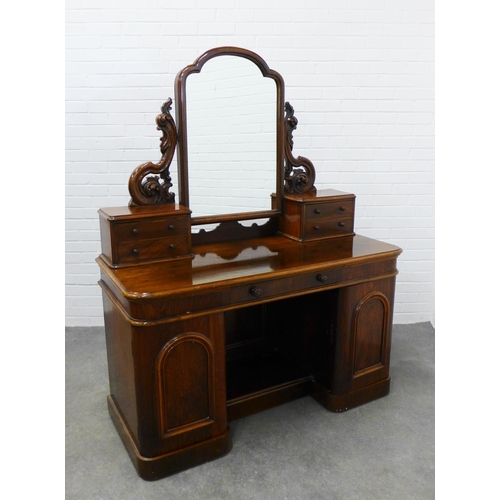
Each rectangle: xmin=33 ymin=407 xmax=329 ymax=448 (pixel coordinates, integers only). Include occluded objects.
xmin=129 ymin=259 xmax=397 ymax=321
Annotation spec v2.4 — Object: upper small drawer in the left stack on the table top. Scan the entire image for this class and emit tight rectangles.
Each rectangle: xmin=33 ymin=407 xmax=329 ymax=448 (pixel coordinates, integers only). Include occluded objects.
xmin=113 ymin=217 xmax=189 ymax=242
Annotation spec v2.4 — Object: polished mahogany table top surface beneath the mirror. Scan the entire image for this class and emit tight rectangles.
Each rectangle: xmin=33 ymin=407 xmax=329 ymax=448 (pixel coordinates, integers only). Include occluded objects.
xmin=97 ymin=235 xmax=402 ymax=298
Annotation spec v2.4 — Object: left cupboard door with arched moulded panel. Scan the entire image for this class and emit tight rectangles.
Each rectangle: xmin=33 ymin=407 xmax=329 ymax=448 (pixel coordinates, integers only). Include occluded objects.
xmin=134 ymin=314 xmax=227 ymax=457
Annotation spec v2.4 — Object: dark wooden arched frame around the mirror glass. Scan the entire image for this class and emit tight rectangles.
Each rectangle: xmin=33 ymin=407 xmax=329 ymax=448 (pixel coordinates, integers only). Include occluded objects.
xmin=175 ymin=46 xmax=285 ymax=225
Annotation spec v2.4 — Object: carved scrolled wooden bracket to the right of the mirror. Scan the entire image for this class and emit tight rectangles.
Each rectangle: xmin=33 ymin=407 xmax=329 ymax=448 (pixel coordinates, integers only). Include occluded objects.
xmin=285 ymin=102 xmax=316 ymax=194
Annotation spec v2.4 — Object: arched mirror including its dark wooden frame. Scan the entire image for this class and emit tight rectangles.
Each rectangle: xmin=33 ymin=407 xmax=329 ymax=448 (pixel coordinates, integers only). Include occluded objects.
xmin=175 ymin=47 xmax=284 ymax=225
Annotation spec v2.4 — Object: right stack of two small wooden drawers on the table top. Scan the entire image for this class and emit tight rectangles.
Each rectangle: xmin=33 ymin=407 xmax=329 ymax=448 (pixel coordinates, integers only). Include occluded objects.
xmin=280 ymin=189 xmax=355 ymax=241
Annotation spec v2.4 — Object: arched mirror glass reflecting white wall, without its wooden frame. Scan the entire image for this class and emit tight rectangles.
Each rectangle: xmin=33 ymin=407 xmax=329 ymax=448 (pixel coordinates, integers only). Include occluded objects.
xmin=186 ymin=55 xmax=277 ymax=217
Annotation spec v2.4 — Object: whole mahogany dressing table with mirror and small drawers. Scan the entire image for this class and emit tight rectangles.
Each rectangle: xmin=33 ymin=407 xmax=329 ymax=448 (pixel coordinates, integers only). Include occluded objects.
xmin=97 ymin=47 xmax=401 ymax=480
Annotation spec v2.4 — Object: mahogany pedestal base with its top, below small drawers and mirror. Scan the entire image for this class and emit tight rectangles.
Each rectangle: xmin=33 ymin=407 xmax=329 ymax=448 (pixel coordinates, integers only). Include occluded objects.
xmin=98 ymin=232 xmax=401 ymax=479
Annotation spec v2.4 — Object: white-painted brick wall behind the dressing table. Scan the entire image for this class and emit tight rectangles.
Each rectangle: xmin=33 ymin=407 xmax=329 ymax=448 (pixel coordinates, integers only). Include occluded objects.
xmin=66 ymin=0 xmax=434 ymax=326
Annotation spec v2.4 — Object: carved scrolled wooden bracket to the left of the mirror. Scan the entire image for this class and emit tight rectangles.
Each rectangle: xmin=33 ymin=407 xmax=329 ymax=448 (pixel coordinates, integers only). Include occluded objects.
xmin=128 ymin=98 xmax=177 ymax=205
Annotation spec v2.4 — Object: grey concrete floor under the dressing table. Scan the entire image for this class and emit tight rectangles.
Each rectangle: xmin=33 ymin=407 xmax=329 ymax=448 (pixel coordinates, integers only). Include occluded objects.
xmin=66 ymin=323 xmax=434 ymax=500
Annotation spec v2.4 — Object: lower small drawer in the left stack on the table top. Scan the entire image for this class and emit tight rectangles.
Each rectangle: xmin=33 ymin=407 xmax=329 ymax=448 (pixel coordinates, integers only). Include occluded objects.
xmin=118 ymin=236 xmax=189 ymax=264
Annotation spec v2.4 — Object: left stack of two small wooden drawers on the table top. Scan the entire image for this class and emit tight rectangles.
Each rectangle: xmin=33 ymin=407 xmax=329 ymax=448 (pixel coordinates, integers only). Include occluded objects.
xmin=99 ymin=204 xmax=192 ymax=268
